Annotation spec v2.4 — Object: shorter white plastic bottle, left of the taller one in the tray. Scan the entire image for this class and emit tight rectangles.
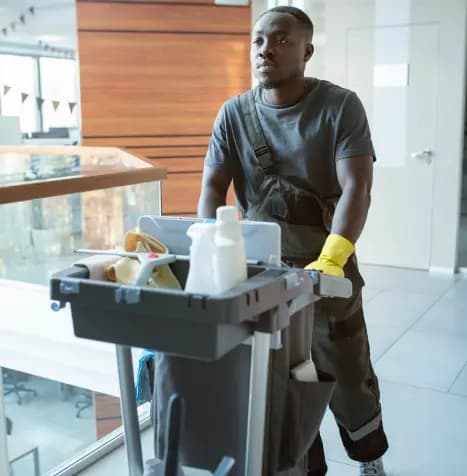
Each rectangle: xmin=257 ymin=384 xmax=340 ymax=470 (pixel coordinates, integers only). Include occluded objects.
xmin=185 ymin=223 xmax=217 ymax=294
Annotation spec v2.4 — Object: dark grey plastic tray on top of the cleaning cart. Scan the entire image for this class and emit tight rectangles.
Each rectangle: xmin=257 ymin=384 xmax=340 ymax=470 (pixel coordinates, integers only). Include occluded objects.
xmin=51 ymin=261 xmax=340 ymax=360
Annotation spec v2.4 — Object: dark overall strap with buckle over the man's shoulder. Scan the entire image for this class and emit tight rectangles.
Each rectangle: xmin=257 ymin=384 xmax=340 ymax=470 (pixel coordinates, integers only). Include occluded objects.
xmin=237 ymin=90 xmax=277 ymax=175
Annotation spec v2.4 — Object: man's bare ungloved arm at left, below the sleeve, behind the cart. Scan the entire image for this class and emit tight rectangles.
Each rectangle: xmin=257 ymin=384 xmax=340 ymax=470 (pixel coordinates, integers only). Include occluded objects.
xmin=198 ymin=166 xmax=232 ymax=218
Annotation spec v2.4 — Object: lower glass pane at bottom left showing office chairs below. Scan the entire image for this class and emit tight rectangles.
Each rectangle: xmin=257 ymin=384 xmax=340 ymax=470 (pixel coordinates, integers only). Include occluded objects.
xmin=3 ymin=368 xmax=100 ymax=476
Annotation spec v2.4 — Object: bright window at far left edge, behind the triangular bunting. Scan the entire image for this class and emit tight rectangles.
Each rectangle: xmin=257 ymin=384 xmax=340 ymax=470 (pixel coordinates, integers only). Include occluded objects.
xmin=0 ymin=55 xmax=39 ymax=132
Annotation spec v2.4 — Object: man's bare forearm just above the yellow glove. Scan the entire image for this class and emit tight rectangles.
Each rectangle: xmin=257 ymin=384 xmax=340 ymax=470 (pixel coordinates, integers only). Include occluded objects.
xmin=331 ymin=186 xmax=370 ymax=244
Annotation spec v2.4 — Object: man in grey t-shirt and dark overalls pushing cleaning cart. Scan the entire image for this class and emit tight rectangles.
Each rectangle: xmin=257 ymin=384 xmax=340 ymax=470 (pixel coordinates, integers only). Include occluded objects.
xmin=198 ymin=6 xmax=388 ymax=476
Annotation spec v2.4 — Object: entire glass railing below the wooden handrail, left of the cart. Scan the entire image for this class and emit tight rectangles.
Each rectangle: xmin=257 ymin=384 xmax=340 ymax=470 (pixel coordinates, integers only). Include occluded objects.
xmin=0 ymin=145 xmax=163 ymax=476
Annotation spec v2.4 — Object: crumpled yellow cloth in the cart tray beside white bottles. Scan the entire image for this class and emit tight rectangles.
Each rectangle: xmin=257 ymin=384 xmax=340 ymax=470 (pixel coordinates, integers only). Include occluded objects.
xmin=106 ymin=231 xmax=182 ymax=289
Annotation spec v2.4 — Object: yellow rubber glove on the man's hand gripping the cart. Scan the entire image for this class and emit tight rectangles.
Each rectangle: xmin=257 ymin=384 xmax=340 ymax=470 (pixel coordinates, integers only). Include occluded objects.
xmin=305 ymin=234 xmax=355 ymax=278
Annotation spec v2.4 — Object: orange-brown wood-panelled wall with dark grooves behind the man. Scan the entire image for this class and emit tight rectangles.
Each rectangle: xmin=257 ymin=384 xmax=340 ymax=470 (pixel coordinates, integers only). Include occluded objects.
xmin=77 ymin=0 xmax=251 ymax=215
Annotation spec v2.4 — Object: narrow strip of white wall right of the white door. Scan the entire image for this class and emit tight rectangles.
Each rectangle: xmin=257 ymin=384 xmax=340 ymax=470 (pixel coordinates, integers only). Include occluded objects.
xmin=430 ymin=0 xmax=466 ymax=268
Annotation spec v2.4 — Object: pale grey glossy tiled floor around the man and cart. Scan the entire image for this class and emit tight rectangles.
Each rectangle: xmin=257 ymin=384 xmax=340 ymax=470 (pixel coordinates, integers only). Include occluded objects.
xmin=81 ymin=266 xmax=467 ymax=476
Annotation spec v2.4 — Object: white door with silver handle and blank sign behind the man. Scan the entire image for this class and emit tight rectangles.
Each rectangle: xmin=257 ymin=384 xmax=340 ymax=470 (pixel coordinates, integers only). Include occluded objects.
xmin=346 ymin=23 xmax=438 ymax=269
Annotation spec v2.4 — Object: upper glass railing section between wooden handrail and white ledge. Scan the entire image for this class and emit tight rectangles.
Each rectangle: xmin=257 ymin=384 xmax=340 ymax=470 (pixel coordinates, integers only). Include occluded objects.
xmin=0 ymin=183 xmax=159 ymax=285
